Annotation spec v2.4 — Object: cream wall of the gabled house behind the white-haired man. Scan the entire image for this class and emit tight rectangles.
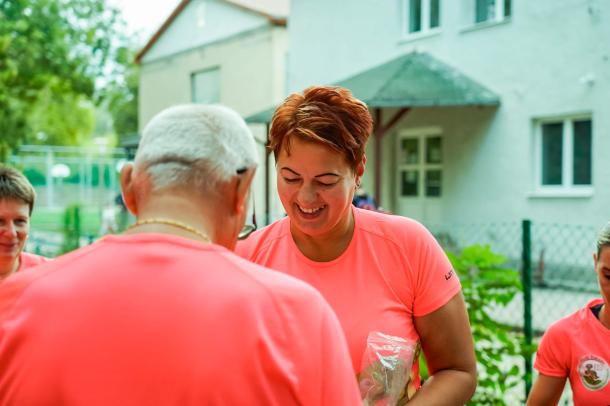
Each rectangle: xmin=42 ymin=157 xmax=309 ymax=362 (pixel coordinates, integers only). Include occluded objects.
xmin=139 ymin=6 xmax=288 ymax=225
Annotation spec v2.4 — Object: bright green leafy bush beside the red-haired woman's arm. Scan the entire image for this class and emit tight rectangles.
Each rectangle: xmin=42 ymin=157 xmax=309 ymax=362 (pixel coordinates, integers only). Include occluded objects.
xmin=447 ymin=245 xmax=523 ymax=405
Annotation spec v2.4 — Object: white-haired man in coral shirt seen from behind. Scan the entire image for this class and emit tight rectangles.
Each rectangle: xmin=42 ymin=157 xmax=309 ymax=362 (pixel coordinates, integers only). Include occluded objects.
xmin=0 ymin=105 xmax=360 ymax=405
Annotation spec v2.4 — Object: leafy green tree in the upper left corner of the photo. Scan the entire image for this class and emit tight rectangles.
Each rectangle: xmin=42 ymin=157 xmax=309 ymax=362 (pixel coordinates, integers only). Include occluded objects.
xmin=0 ymin=0 xmax=121 ymax=159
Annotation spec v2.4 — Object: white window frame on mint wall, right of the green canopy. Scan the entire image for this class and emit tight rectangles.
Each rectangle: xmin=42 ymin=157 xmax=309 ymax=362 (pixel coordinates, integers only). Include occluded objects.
xmin=531 ymin=113 xmax=595 ymax=197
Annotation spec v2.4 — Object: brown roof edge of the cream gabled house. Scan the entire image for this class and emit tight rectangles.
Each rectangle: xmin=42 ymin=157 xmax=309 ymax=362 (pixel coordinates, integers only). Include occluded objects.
xmin=136 ymin=0 xmax=288 ymax=64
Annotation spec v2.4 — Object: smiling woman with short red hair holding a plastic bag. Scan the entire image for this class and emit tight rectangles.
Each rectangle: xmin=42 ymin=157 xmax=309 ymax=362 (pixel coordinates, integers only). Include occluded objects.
xmin=237 ymin=86 xmax=476 ymax=405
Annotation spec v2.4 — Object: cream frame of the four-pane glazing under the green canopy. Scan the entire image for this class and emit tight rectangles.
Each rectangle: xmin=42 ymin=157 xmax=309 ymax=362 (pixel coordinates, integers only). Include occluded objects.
xmin=396 ymin=127 xmax=445 ymax=199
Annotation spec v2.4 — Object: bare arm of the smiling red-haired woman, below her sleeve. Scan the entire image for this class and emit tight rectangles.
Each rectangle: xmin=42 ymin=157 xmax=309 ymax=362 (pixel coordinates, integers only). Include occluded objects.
xmin=409 ymin=292 xmax=477 ymax=406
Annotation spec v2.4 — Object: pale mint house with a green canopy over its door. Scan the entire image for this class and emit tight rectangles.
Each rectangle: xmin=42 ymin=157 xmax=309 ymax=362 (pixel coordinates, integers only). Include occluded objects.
xmin=251 ymin=0 xmax=610 ymax=235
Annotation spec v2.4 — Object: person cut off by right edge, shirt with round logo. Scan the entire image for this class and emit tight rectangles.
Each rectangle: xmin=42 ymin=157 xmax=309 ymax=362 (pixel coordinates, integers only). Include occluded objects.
xmin=527 ymin=222 xmax=610 ymax=406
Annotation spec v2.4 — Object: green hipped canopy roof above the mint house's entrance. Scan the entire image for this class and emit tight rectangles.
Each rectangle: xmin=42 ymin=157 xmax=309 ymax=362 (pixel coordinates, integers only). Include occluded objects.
xmin=246 ymin=52 xmax=500 ymax=123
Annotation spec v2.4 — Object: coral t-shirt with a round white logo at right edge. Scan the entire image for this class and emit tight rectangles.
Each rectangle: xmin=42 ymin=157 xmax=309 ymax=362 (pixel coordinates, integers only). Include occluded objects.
xmin=534 ymin=299 xmax=610 ymax=406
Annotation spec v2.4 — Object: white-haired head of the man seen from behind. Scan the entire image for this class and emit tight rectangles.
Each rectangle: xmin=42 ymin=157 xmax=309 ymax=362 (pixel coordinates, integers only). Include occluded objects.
xmin=121 ymin=105 xmax=258 ymax=251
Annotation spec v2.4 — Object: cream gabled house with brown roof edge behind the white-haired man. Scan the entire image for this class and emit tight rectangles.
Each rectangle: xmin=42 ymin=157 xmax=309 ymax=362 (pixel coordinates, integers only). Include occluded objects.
xmin=137 ymin=0 xmax=288 ymax=222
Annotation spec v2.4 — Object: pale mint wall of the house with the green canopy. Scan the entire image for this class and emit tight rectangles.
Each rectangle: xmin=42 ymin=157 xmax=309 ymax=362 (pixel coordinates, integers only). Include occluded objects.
xmin=289 ymin=0 xmax=610 ymax=225
